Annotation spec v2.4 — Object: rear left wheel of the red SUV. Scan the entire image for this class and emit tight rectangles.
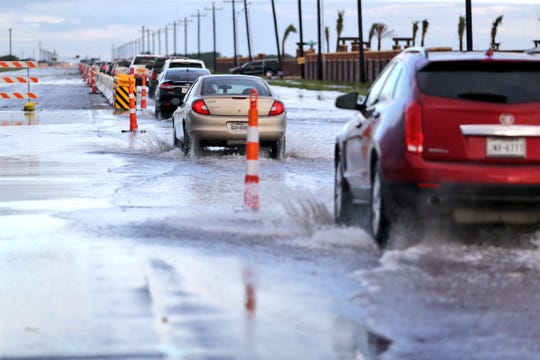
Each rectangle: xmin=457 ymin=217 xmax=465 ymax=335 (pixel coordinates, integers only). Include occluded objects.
xmin=369 ymin=161 xmax=391 ymax=248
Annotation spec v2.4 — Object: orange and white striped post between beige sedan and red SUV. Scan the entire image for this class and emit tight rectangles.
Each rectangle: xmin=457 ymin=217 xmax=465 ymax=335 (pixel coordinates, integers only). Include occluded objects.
xmin=244 ymin=89 xmax=259 ymax=210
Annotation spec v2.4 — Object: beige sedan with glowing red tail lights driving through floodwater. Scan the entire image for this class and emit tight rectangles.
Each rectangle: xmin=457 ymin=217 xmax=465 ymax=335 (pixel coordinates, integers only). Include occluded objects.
xmin=173 ymin=75 xmax=287 ymax=159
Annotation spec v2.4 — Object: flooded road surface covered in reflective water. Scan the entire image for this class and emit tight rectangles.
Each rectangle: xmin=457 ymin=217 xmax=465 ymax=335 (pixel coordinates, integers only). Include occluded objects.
xmin=0 ymin=69 xmax=540 ymax=359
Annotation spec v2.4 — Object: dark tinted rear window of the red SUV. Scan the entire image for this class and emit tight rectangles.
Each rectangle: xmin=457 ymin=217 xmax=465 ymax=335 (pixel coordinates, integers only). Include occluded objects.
xmin=417 ymin=61 xmax=540 ymax=104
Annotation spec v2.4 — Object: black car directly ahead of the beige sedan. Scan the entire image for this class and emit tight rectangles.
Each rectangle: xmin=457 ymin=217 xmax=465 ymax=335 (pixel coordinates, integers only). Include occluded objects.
xmin=155 ymin=67 xmax=210 ymax=119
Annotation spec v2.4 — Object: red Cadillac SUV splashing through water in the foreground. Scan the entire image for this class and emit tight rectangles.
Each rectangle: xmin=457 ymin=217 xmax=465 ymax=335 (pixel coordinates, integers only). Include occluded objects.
xmin=334 ymin=48 xmax=540 ymax=246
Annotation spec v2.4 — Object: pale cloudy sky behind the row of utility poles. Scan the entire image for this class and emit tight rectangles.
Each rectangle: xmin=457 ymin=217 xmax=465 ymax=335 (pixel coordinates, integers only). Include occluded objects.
xmin=0 ymin=0 xmax=540 ymax=60
